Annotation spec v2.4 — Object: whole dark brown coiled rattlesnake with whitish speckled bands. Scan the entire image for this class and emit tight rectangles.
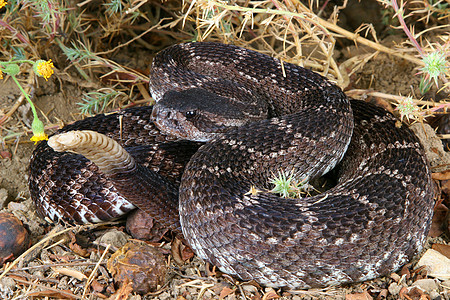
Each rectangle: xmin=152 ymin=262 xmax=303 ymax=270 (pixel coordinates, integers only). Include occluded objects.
xmin=29 ymin=43 xmax=434 ymax=288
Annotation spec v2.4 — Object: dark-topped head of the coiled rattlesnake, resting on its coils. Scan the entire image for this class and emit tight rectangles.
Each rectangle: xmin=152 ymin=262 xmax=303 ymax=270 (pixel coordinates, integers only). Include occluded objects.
xmin=152 ymin=88 xmax=261 ymax=142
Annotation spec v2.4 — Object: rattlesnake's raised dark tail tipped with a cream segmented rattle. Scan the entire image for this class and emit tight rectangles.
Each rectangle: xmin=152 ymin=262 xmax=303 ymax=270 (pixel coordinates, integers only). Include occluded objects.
xmin=48 ymin=130 xmax=181 ymax=232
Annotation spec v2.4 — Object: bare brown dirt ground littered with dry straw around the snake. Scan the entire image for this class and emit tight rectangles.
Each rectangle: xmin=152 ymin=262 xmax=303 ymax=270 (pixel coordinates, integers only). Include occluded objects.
xmin=0 ymin=6 xmax=450 ymax=300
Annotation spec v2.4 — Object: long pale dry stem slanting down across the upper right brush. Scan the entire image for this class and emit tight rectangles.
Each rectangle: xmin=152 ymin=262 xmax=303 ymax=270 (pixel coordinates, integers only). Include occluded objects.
xmin=210 ymin=1 xmax=425 ymax=66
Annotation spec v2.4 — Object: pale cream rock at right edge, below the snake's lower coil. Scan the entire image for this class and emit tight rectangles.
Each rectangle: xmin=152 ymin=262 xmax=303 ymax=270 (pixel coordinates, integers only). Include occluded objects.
xmin=417 ymin=249 xmax=450 ymax=280
